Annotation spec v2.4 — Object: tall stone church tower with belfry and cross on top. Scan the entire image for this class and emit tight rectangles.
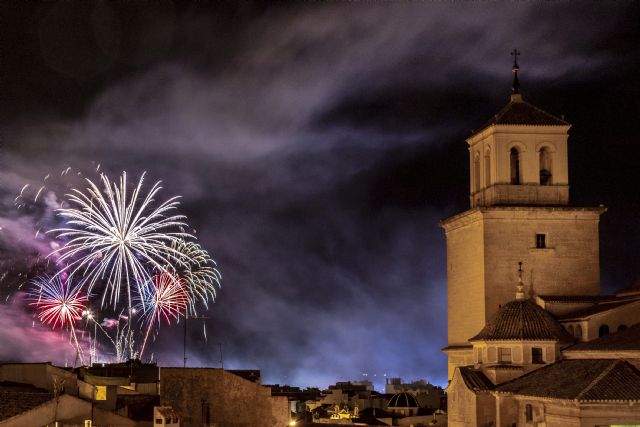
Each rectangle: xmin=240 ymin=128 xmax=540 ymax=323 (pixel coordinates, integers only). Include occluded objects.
xmin=440 ymin=51 xmax=606 ymax=379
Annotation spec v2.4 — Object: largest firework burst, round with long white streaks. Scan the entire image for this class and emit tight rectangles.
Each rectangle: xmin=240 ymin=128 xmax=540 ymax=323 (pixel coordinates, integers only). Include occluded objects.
xmin=50 ymin=173 xmax=194 ymax=309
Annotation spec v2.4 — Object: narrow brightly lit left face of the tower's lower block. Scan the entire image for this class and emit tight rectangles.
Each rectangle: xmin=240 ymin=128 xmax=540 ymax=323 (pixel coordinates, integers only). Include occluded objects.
xmin=445 ymin=212 xmax=485 ymax=345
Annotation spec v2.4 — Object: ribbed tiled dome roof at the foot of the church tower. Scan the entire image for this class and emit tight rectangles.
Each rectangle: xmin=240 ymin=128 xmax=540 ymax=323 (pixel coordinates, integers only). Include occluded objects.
xmin=469 ymin=300 xmax=573 ymax=342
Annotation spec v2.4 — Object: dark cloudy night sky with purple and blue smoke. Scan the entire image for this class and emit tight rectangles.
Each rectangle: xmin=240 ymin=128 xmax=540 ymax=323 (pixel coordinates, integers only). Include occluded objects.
xmin=0 ymin=2 xmax=640 ymax=388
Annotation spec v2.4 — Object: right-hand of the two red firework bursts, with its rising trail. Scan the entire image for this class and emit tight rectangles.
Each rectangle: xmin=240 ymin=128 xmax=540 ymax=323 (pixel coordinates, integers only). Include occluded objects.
xmin=140 ymin=272 xmax=191 ymax=358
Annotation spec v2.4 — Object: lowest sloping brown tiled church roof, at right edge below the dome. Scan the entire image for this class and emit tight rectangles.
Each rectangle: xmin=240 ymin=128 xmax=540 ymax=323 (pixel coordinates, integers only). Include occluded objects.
xmin=496 ymin=359 xmax=640 ymax=402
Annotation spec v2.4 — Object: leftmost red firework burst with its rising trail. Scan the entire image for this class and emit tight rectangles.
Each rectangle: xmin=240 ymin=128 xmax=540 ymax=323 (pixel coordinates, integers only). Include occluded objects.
xmin=29 ymin=275 xmax=88 ymax=365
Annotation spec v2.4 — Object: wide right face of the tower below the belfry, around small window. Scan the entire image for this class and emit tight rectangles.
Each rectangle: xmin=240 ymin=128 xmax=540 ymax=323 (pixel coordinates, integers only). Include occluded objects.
xmin=478 ymin=207 xmax=600 ymax=329
